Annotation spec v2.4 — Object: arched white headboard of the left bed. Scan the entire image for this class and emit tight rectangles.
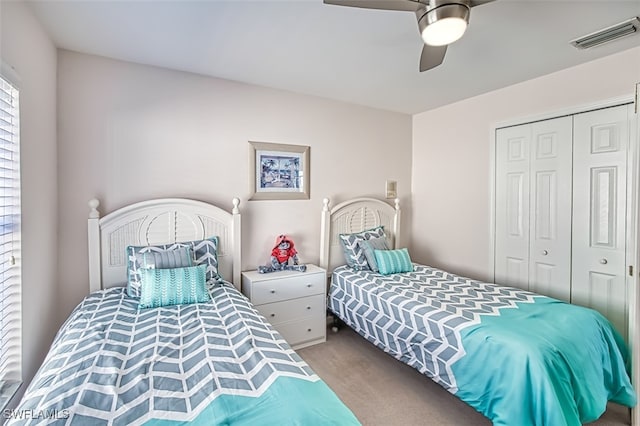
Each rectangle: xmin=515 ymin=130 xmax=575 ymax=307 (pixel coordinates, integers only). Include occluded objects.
xmin=88 ymin=198 xmax=242 ymax=291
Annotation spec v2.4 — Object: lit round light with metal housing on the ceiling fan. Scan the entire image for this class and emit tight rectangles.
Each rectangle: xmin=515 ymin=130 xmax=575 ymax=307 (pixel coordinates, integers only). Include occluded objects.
xmin=418 ymin=3 xmax=469 ymax=46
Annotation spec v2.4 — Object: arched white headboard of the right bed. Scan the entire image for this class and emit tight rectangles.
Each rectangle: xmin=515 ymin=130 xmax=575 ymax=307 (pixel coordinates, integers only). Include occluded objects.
xmin=320 ymin=198 xmax=400 ymax=274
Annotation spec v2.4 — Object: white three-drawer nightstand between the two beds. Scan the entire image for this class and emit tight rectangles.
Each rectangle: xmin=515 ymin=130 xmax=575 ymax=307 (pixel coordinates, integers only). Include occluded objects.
xmin=242 ymin=265 xmax=327 ymax=349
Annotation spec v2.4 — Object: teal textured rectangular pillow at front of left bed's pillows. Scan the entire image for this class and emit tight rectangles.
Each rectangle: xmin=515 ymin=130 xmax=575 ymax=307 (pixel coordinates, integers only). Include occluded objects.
xmin=138 ymin=264 xmax=210 ymax=308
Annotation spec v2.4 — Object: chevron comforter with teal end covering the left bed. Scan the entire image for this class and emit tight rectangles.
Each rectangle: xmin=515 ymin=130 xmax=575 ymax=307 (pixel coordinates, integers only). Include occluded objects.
xmin=10 ymin=283 xmax=359 ymax=425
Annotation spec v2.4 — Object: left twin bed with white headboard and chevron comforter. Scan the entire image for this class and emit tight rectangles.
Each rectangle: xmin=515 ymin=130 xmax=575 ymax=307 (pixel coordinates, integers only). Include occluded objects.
xmin=10 ymin=199 xmax=359 ymax=425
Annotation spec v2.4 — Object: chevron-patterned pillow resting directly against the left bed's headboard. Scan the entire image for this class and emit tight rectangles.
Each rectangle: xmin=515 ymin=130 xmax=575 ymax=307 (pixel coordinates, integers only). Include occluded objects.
xmin=127 ymin=237 xmax=222 ymax=297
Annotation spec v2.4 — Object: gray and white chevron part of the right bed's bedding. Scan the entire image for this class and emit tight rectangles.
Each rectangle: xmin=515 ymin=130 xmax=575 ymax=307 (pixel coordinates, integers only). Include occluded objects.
xmin=328 ymin=265 xmax=534 ymax=393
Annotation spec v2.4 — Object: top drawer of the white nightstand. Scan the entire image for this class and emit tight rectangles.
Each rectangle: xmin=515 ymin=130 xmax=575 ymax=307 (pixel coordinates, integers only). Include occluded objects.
xmin=251 ymin=272 xmax=327 ymax=305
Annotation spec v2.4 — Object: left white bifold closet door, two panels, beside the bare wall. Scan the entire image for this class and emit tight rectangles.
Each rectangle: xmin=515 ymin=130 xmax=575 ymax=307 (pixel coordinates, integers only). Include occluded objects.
xmin=495 ymin=117 xmax=572 ymax=301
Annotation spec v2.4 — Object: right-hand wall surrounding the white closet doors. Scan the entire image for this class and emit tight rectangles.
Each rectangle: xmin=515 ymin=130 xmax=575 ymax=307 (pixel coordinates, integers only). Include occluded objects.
xmin=411 ymin=47 xmax=640 ymax=279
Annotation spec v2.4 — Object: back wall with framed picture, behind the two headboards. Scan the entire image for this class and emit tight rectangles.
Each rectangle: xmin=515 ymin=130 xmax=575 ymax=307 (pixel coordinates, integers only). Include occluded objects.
xmin=58 ymin=51 xmax=411 ymax=321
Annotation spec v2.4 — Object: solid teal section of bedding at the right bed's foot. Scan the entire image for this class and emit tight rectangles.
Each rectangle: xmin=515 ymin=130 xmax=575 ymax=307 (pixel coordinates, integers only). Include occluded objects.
xmin=453 ymin=297 xmax=636 ymax=426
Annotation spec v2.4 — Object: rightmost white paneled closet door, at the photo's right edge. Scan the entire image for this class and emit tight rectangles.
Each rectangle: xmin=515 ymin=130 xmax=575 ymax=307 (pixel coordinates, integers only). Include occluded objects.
xmin=571 ymin=105 xmax=631 ymax=337
